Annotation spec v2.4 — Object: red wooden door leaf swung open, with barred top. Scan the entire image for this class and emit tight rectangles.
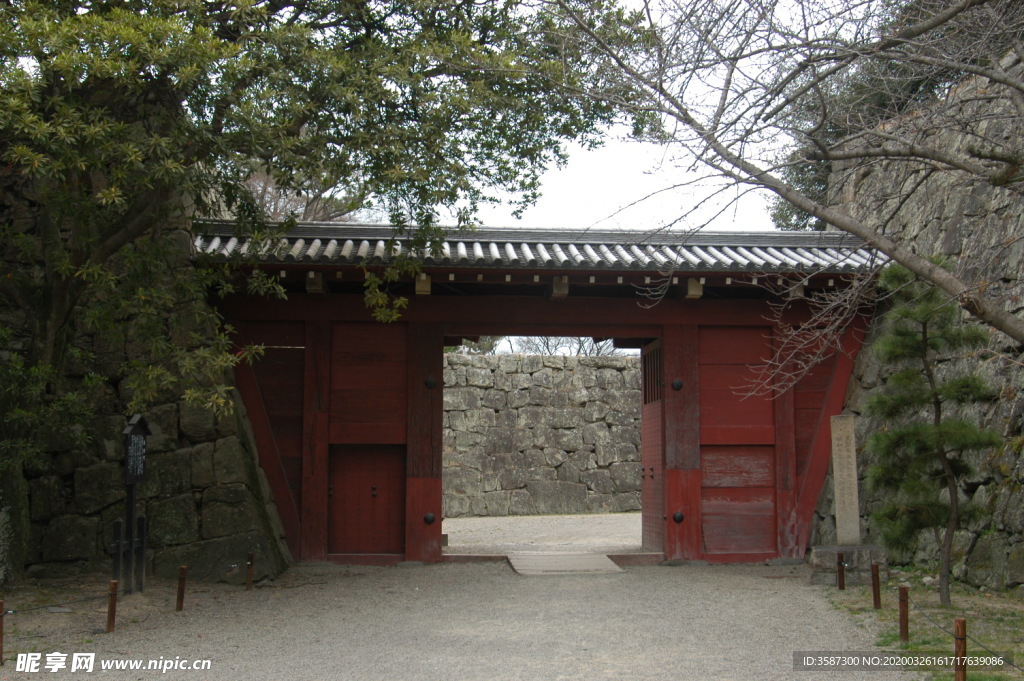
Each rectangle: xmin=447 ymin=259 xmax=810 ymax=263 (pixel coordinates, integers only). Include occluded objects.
xmin=640 ymin=340 xmax=665 ymax=551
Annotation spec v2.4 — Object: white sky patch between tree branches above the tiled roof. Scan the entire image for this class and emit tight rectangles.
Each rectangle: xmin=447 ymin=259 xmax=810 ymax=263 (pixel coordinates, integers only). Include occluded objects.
xmin=471 ymin=136 xmax=773 ymax=231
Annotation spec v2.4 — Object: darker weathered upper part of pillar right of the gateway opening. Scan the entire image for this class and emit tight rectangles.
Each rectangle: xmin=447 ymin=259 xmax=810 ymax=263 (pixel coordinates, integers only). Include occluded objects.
xmin=662 ymin=326 xmax=705 ymax=470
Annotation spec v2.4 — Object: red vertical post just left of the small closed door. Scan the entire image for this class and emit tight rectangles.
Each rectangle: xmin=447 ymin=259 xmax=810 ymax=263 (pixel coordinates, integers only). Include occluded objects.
xmin=301 ymin=322 xmax=331 ymax=560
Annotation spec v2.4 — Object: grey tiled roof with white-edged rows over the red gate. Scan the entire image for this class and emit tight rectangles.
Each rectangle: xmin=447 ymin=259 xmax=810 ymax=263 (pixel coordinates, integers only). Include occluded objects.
xmin=196 ymin=223 xmax=884 ymax=273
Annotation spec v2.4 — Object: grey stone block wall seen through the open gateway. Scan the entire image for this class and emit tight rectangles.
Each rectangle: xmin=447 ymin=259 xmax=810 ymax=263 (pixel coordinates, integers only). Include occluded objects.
xmin=443 ymin=354 xmax=641 ymax=517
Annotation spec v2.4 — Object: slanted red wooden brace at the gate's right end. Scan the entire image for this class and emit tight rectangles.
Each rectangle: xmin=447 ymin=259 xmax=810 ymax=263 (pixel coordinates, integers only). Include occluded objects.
xmin=796 ymin=316 xmax=868 ymax=555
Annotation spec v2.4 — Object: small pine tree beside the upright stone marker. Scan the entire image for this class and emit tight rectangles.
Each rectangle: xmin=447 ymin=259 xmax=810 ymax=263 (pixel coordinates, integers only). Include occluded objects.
xmin=867 ymin=265 xmax=1000 ymax=605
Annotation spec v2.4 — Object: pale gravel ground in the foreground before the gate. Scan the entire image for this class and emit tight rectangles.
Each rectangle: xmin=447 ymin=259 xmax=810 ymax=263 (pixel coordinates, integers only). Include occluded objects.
xmin=0 ymin=516 xmax=920 ymax=681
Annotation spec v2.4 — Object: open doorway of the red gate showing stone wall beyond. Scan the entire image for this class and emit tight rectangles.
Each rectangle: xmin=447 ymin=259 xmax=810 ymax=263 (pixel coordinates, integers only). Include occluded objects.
xmin=442 ymin=336 xmax=647 ymax=555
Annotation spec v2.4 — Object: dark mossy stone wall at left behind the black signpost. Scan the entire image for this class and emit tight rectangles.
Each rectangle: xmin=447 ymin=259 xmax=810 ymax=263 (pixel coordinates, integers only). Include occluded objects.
xmin=27 ymin=393 xmax=291 ymax=582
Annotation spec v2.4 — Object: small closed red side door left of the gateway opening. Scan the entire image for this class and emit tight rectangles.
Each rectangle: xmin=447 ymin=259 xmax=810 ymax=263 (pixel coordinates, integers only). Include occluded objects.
xmin=328 ymin=444 xmax=406 ymax=554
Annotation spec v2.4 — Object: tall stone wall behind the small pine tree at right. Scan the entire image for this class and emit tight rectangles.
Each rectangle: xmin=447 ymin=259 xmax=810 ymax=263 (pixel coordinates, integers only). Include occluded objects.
xmin=812 ymin=59 xmax=1024 ymax=588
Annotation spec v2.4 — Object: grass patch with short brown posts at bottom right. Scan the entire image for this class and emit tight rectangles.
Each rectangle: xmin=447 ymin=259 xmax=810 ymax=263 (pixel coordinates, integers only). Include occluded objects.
xmin=831 ymin=568 xmax=1024 ymax=681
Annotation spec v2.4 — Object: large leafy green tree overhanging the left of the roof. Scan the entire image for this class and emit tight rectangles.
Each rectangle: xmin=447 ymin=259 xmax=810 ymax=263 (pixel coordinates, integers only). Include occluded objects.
xmin=0 ymin=0 xmax=634 ymax=466
